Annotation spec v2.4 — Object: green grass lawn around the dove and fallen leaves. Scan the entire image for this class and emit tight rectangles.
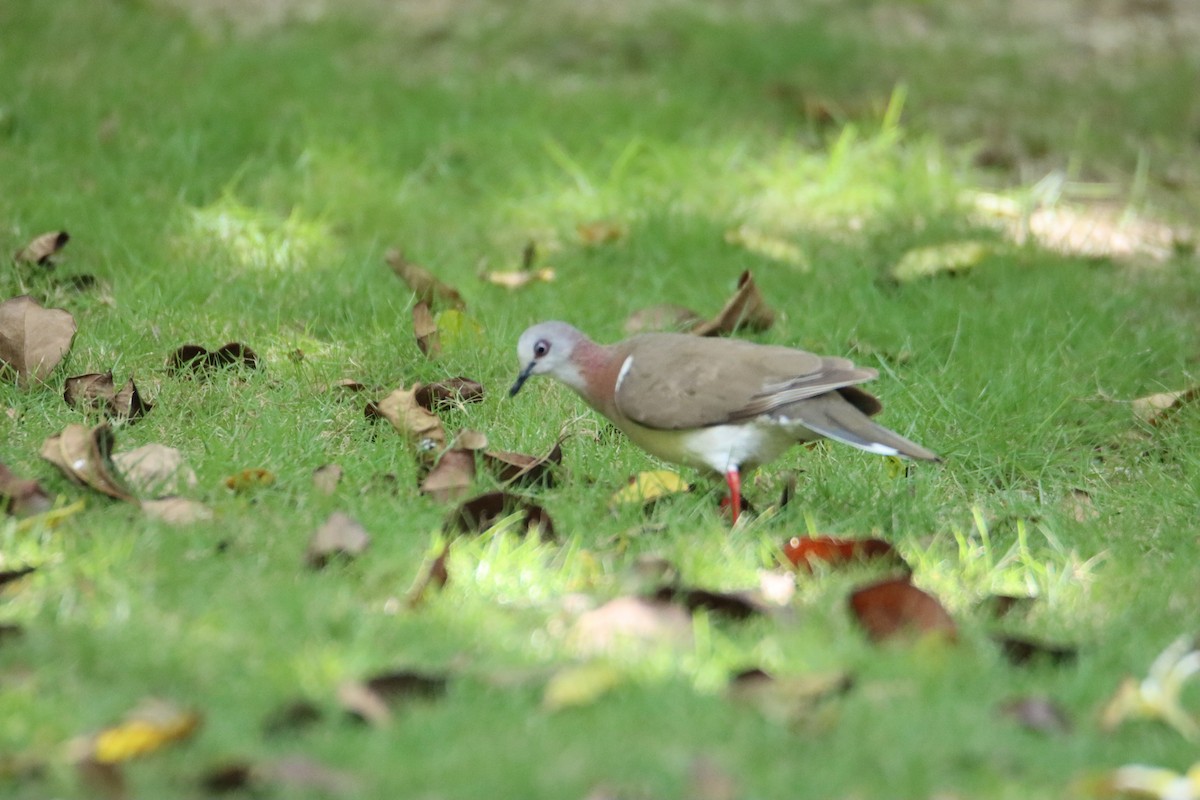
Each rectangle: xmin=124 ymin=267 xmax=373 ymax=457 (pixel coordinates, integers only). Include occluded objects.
xmin=0 ymin=0 xmax=1200 ymax=798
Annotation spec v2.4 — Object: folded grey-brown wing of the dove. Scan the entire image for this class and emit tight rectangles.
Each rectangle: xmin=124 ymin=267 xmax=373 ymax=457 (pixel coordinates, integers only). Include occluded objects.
xmin=614 ymin=333 xmax=877 ymax=429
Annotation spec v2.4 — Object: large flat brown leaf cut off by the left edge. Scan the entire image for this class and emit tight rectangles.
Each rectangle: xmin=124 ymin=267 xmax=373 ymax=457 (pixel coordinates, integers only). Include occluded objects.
xmin=0 ymin=295 xmax=76 ymax=386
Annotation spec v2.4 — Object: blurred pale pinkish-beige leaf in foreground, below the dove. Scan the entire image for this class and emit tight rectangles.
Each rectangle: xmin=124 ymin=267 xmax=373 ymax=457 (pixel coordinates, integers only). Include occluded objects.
xmin=569 ymin=597 xmax=692 ymax=654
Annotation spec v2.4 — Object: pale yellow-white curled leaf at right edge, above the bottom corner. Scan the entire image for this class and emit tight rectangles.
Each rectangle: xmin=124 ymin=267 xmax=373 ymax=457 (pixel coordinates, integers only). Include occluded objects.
xmin=1100 ymin=636 xmax=1200 ymax=741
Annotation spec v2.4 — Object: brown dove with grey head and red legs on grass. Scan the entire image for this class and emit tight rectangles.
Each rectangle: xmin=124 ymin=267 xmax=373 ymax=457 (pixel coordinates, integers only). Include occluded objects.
xmin=509 ymin=320 xmax=941 ymax=524
